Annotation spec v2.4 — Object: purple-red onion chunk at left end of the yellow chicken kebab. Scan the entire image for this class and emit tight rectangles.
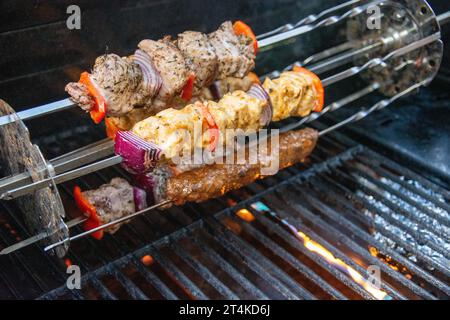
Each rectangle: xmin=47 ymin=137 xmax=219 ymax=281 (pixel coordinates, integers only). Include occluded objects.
xmin=114 ymin=131 xmax=162 ymax=173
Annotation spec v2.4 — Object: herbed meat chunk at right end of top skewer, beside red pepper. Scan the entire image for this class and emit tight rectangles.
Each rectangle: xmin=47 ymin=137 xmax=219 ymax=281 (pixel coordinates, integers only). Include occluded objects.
xmin=208 ymin=21 xmax=256 ymax=79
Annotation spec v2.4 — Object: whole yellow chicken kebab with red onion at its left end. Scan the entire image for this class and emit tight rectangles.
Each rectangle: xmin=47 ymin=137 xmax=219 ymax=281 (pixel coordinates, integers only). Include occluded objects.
xmin=115 ymin=69 xmax=323 ymax=173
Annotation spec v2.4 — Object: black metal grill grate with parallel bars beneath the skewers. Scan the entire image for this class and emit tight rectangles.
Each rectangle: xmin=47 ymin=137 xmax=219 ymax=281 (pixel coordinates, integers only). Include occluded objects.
xmin=0 ymin=118 xmax=442 ymax=299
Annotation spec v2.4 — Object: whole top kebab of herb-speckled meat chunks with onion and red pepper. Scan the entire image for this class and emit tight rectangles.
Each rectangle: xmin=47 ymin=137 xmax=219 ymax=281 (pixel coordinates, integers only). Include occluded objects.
xmin=66 ymin=22 xmax=256 ymax=123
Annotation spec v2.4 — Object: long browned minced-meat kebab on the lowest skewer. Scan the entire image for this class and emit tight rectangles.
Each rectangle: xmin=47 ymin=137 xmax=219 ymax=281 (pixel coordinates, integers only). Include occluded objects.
xmin=165 ymin=128 xmax=318 ymax=205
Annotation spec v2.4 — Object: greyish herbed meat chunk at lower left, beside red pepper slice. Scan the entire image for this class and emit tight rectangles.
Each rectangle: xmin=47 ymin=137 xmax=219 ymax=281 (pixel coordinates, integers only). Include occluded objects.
xmin=83 ymin=178 xmax=136 ymax=233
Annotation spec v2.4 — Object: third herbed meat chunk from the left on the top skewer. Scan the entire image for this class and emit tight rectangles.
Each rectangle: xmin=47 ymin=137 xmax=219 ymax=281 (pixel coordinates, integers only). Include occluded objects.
xmin=176 ymin=31 xmax=218 ymax=89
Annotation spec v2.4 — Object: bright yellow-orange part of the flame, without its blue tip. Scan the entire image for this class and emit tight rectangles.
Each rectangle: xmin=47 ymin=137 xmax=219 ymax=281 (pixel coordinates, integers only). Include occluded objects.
xmin=297 ymin=231 xmax=387 ymax=300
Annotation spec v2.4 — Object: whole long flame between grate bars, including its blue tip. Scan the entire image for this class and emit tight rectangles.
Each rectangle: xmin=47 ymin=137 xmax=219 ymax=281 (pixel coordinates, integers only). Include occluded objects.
xmin=251 ymin=202 xmax=390 ymax=300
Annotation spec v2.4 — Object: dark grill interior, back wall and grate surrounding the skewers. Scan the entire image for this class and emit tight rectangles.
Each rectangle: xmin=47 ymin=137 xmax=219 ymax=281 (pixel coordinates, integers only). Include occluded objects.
xmin=0 ymin=0 xmax=450 ymax=299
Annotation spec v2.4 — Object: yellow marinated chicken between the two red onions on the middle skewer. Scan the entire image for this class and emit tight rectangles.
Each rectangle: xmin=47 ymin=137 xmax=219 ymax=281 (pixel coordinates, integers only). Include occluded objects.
xmin=128 ymin=91 xmax=268 ymax=159
